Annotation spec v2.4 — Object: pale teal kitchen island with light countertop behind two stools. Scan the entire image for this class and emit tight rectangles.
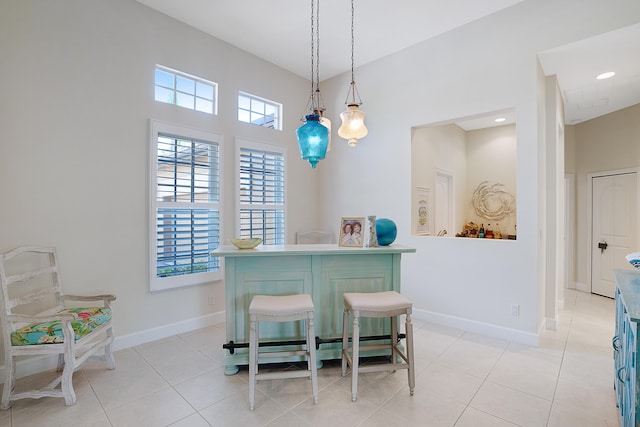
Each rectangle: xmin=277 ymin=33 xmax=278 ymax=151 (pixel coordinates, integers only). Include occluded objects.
xmin=212 ymin=245 xmax=416 ymax=375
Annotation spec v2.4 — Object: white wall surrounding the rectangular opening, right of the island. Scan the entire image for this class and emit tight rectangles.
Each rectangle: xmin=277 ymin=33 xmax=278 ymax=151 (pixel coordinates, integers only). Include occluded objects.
xmin=319 ymin=0 xmax=640 ymax=341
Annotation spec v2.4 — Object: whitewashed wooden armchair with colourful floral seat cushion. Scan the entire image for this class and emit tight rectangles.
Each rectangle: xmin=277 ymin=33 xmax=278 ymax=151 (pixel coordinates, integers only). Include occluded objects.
xmin=0 ymin=246 xmax=116 ymax=409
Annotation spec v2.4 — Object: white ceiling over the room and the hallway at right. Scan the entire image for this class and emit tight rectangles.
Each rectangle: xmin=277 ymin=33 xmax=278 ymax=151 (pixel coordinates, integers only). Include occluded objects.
xmin=137 ymin=0 xmax=640 ymax=127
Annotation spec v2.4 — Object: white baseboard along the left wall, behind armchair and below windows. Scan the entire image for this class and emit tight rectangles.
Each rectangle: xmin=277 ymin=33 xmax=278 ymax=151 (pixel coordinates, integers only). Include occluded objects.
xmin=0 ymin=311 xmax=225 ymax=378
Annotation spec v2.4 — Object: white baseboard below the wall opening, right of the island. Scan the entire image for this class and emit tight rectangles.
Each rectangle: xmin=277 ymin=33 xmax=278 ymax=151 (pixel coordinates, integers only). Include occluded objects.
xmin=412 ymin=308 xmax=538 ymax=347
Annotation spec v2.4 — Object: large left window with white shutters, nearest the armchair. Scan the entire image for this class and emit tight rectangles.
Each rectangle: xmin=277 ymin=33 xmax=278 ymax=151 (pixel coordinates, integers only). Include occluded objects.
xmin=149 ymin=121 xmax=222 ymax=291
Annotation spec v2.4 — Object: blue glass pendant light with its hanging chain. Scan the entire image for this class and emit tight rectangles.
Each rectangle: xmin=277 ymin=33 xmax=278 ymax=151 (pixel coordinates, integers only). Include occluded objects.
xmin=296 ymin=0 xmax=331 ymax=169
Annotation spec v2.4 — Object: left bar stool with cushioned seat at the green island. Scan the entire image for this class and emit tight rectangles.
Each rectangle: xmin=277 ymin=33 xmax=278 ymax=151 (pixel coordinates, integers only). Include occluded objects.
xmin=249 ymin=294 xmax=318 ymax=411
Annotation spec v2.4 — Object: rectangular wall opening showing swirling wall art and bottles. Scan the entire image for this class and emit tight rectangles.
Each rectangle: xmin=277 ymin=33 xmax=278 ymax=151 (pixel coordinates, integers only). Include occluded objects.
xmin=411 ymin=109 xmax=517 ymax=240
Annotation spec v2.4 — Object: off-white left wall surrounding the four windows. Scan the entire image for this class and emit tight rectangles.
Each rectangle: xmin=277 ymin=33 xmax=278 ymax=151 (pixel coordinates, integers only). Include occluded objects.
xmin=0 ymin=0 xmax=318 ymax=358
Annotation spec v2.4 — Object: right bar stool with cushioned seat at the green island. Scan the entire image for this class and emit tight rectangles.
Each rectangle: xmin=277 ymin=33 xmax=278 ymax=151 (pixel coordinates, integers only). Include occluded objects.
xmin=342 ymin=291 xmax=416 ymax=402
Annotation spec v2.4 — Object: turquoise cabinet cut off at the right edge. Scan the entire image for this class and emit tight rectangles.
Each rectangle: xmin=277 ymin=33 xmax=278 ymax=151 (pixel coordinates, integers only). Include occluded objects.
xmin=612 ymin=270 xmax=640 ymax=427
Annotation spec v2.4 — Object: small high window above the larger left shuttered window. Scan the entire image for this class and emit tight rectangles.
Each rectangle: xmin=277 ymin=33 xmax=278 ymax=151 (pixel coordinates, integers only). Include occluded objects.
xmin=155 ymin=65 xmax=218 ymax=114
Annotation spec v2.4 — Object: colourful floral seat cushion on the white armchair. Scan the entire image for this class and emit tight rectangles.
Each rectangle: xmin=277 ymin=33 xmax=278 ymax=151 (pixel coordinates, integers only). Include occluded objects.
xmin=11 ymin=307 xmax=111 ymax=346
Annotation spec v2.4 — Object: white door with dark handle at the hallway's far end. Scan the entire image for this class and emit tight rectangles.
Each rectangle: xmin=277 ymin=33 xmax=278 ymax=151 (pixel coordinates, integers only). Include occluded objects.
xmin=591 ymin=172 xmax=638 ymax=298
